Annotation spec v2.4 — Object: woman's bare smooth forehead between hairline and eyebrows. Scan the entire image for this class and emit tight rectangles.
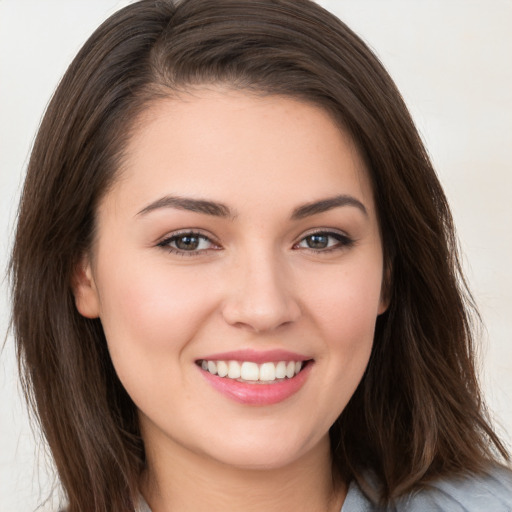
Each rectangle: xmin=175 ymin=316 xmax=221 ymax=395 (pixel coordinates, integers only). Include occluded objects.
xmin=105 ymin=88 xmax=373 ymax=216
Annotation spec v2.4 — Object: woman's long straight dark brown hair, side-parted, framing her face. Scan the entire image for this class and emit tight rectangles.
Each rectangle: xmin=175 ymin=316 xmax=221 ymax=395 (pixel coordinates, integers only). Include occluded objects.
xmin=10 ymin=0 xmax=508 ymax=512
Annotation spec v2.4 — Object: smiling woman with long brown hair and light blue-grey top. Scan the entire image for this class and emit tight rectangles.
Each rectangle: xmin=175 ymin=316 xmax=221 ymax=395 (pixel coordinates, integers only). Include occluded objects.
xmin=11 ymin=0 xmax=512 ymax=512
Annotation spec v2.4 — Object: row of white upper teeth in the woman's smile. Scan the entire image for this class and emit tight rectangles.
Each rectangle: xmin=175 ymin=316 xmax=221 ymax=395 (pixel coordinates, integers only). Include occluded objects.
xmin=201 ymin=359 xmax=303 ymax=382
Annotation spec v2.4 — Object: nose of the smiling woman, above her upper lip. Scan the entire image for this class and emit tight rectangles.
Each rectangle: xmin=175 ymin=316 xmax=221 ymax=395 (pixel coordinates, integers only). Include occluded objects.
xmin=222 ymin=253 xmax=301 ymax=333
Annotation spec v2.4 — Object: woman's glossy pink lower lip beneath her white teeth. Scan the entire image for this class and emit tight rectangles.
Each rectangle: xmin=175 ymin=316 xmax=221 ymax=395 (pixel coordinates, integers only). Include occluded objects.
xmin=199 ymin=361 xmax=313 ymax=405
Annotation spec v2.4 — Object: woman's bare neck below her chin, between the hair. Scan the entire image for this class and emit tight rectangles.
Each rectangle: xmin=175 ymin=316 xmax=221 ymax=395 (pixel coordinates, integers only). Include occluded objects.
xmin=141 ymin=430 xmax=346 ymax=512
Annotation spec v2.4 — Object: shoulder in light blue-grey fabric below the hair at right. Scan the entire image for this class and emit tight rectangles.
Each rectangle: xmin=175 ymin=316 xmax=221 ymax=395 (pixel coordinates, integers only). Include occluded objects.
xmin=395 ymin=468 xmax=512 ymax=512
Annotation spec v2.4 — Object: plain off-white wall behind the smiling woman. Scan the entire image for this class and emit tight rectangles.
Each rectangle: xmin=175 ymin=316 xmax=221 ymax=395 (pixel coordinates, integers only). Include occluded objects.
xmin=0 ymin=0 xmax=512 ymax=512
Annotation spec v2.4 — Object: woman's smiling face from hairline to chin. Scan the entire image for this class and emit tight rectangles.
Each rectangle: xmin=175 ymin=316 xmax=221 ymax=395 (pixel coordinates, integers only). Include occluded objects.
xmin=75 ymin=90 xmax=386 ymax=468
